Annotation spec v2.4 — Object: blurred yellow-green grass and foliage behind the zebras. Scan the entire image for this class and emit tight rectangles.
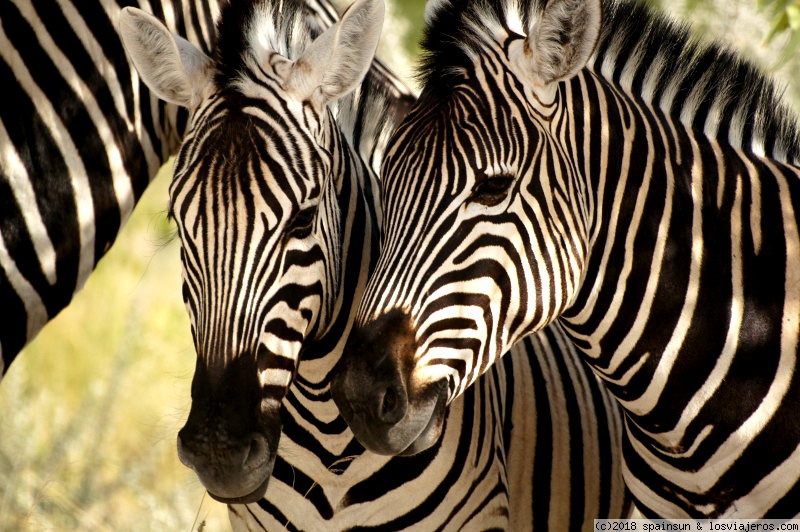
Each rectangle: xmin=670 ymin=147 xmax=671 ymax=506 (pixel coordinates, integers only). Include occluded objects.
xmin=0 ymin=0 xmax=800 ymax=531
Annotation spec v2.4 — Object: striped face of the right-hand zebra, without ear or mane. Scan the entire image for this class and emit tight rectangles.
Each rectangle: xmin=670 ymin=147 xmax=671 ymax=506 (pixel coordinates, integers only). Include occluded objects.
xmin=334 ymin=66 xmax=584 ymax=454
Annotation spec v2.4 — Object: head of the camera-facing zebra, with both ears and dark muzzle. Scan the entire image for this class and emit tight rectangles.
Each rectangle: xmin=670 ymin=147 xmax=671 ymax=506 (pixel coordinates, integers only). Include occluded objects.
xmin=121 ymin=0 xmax=384 ymax=503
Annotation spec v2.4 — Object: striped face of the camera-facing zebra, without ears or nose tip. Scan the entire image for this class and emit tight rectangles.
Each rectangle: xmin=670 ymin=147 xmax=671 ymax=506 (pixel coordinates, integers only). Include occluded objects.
xmin=170 ymin=70 xmax=341 ymax=500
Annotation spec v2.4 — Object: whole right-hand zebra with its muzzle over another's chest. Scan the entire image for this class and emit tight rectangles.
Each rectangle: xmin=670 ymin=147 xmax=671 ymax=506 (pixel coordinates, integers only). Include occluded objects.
xmin=332 ymin=0 xmax=800 ymax=518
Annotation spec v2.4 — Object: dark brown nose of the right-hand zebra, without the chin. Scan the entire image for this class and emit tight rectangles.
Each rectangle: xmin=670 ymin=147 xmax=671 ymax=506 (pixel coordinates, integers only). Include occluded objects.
xmin=331 ymin=311 xmax=414 ymax=454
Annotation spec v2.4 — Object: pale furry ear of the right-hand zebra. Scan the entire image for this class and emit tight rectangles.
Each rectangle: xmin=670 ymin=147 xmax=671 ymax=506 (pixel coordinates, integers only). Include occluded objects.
xmin=518 ymin=0 xmax=602 ymax=88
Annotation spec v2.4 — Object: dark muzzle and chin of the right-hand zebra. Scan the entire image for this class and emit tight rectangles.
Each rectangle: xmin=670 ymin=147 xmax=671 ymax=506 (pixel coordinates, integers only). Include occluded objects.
xmin=331 ymin=311 xmax=448 ymax=455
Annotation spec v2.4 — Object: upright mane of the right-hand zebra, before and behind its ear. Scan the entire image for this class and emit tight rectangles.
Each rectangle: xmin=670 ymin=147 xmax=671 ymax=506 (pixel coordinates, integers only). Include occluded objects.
xmin=417 ymin=0 xmax=800 ymax=165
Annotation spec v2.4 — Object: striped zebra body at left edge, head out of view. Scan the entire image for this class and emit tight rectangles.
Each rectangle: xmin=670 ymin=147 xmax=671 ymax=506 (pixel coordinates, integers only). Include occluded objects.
xmin=0 ymin=0 xmax=219 ymax=379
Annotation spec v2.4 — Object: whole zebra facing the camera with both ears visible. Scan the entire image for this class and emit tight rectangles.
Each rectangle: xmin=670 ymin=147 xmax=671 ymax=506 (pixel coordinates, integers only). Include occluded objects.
xmin=121 ymin=0 xmax=628 ymax=530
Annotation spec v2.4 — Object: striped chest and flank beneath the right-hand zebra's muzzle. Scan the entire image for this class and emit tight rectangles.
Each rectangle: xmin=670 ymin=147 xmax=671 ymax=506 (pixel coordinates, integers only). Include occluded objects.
xmin=238 ymin=329 xmax=630 ymax=530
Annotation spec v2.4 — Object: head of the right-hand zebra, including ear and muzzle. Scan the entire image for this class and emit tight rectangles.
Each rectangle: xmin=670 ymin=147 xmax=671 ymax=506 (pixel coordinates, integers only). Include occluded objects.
xmin=332 ymin=0 xmax=601 ymax=454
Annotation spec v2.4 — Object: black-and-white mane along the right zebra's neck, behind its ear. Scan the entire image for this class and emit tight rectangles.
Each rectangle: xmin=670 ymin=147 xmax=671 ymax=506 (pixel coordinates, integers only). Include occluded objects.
xmin=590 ymin=0 xmax=800 ymax=165
